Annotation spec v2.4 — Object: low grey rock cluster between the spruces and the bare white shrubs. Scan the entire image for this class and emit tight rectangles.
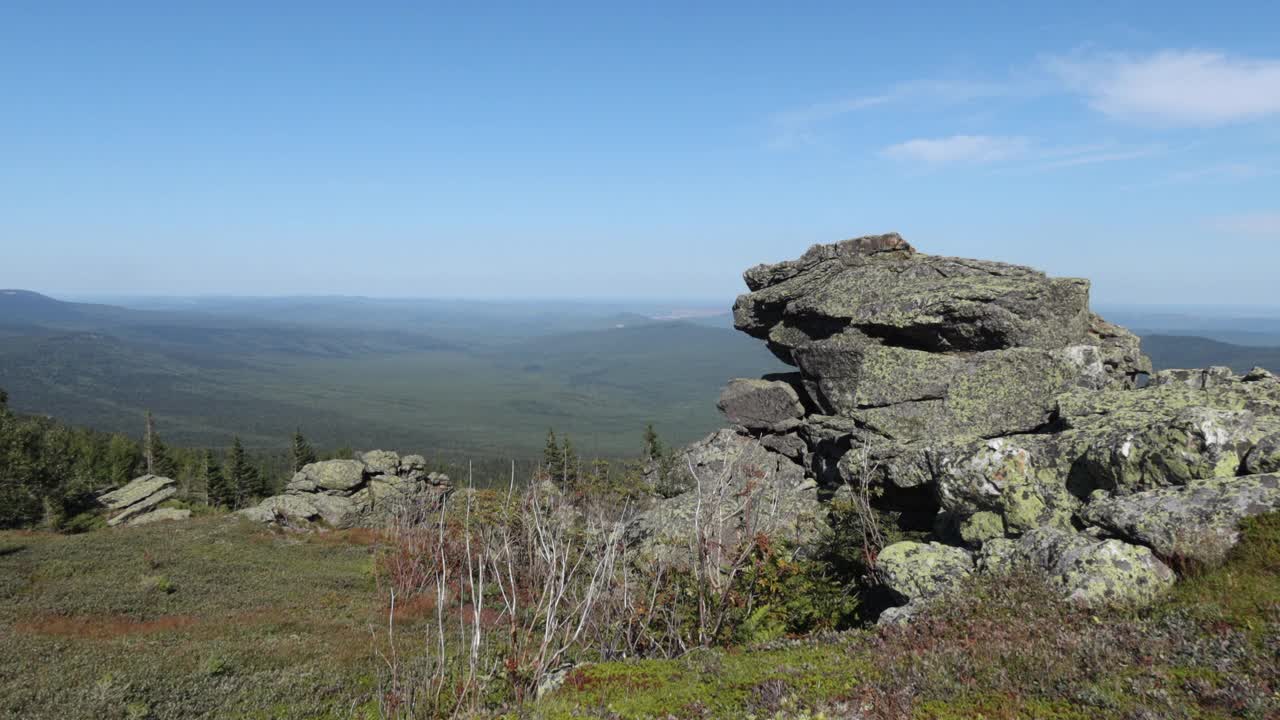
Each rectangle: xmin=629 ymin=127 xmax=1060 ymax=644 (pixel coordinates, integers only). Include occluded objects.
xmin=239 ymin=450 xmax=452 ymax=528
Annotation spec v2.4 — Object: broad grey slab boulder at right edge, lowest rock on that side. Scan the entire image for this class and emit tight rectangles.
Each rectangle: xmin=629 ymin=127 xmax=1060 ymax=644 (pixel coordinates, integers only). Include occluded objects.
xmin=1083 ymin=474 xmax=1280 ymax=564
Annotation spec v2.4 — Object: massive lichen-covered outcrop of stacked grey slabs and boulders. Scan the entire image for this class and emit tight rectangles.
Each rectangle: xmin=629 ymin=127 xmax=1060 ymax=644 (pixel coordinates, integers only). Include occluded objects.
xmin=670 ymin=234 xmax=1280 ymax=619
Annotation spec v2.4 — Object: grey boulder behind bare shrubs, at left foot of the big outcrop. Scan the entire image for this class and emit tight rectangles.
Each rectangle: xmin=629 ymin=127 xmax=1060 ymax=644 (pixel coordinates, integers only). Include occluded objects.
xmin=627 ymin=429 xmax=826 ymax=560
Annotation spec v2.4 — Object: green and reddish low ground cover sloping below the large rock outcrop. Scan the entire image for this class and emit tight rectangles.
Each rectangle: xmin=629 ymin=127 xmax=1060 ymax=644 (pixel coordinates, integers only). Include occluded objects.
xmin=536 ymin=515 xmax=1280 ymax=720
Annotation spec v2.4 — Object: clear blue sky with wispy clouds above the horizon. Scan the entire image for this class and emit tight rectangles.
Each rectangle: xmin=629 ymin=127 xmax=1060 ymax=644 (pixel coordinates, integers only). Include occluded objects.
xmin=0 ymin=0 xmax=1280 ymax=305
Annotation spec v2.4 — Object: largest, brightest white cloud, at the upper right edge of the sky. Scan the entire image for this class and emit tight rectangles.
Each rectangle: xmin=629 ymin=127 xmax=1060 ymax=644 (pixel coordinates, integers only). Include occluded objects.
xmin=1047 ymin=50 xmax=1280 ymax=126
